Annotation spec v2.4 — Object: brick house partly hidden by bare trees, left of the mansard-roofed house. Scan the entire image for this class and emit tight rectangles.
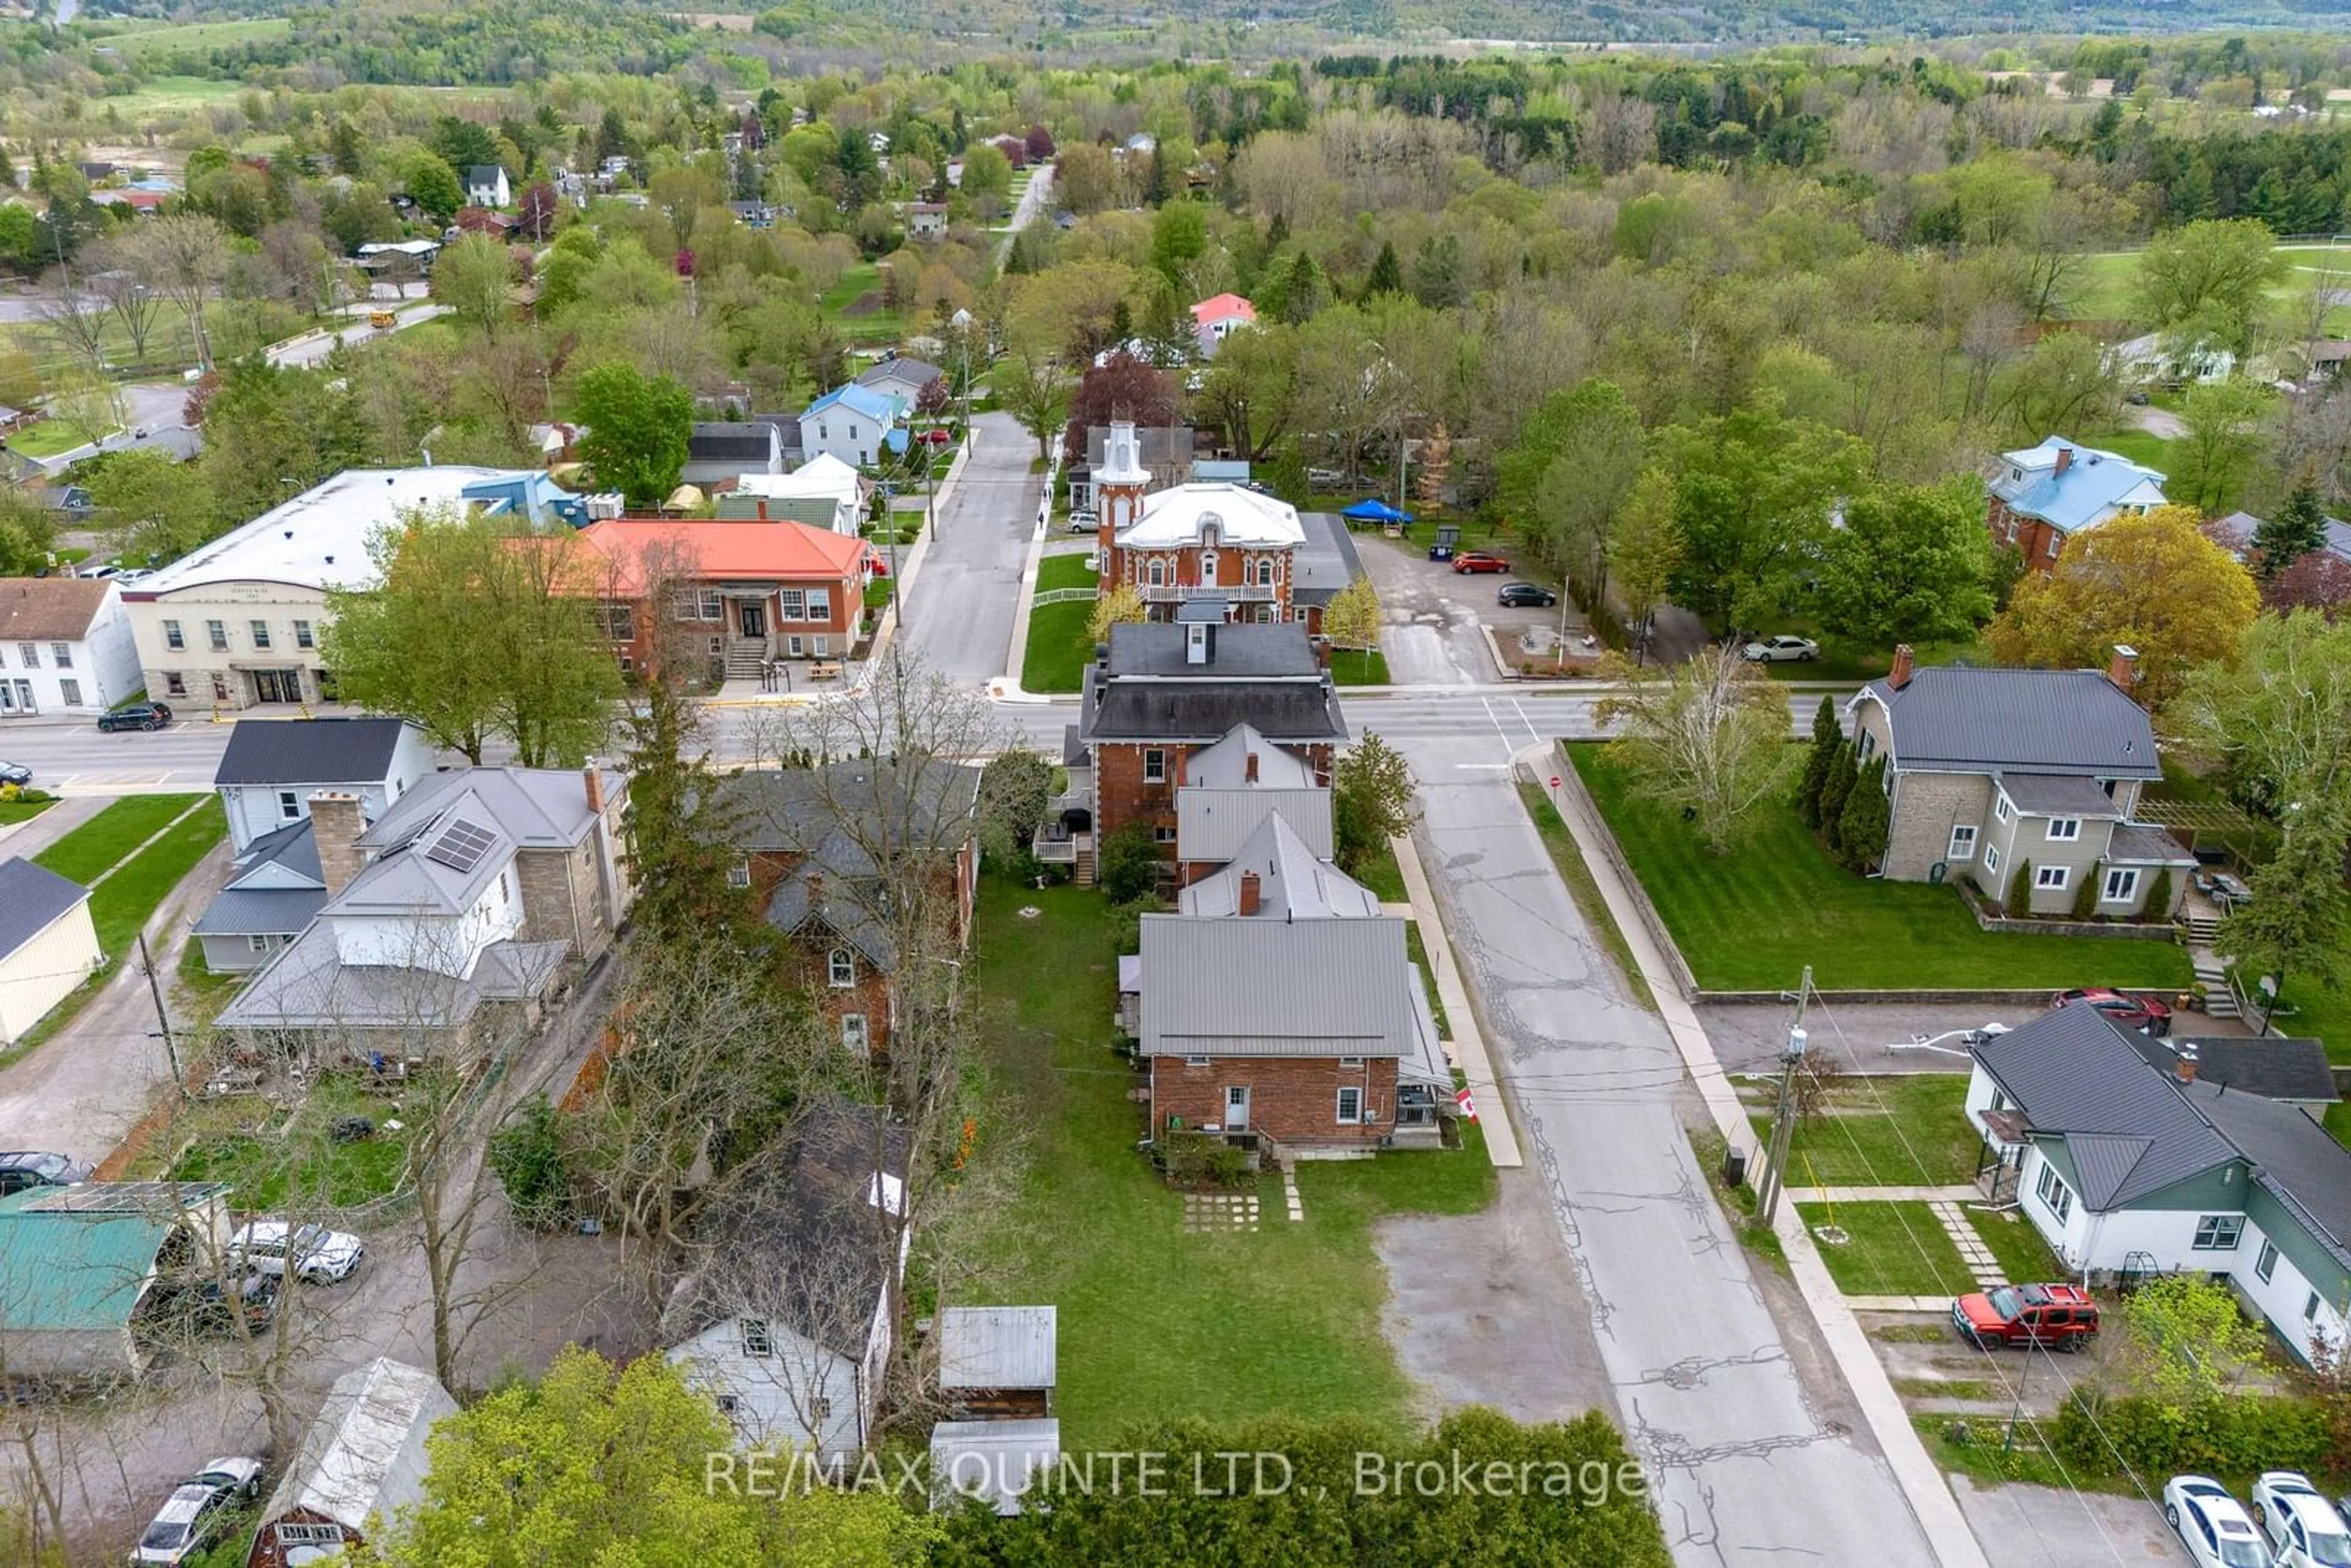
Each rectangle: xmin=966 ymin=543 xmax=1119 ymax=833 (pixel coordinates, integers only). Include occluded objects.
xmin=722 ymin=757 xmax=980 ymax=1053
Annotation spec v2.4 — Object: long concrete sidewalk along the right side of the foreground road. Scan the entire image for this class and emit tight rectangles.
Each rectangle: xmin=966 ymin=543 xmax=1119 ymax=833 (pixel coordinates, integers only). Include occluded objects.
xmin=1519 ymin=745 xmax=1989 ymax=1568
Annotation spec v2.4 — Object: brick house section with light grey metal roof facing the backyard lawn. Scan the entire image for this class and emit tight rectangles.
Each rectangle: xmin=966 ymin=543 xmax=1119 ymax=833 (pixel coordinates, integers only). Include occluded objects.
xmin=1140 ymin=813 xmax=1453 ymax=1147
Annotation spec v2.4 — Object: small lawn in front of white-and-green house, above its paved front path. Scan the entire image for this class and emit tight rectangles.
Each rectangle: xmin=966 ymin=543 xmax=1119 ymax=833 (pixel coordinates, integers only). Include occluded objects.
xmin=1754 ymin=1072 xmax=1982 ymax=1187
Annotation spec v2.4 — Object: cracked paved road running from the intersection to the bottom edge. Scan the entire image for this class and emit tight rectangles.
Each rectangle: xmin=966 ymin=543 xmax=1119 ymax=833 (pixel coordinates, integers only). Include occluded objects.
xmin=1361 ymin=705 xmax=1935 ymax=1568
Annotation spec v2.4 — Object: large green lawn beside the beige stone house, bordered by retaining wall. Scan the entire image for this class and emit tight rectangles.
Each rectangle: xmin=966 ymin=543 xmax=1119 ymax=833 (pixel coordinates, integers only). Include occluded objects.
xmin=1568 ymin=743 xmax=2189 ymax=989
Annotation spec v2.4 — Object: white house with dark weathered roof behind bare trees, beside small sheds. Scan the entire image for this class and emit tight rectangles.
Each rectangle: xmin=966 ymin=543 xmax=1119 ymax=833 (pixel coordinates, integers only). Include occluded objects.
xmin=663 ymin=1100 xmax=907 ymax=1465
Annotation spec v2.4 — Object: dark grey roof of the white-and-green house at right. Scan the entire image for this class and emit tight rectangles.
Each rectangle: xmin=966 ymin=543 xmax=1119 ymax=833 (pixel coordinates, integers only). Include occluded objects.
xmin=1970 ymin=1006 xmax=2236 ymax=1213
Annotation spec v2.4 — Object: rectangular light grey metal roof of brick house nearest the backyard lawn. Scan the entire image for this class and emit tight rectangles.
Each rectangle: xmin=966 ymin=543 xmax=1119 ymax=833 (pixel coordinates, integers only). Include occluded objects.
xmin=1142 ymin=915 xmax=1413 ymax=1056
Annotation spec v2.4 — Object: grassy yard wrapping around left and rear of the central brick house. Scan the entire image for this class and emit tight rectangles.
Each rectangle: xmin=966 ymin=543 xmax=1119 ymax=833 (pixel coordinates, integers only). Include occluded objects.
xmin=976 ymin=879 xmax=1495 ymax=1448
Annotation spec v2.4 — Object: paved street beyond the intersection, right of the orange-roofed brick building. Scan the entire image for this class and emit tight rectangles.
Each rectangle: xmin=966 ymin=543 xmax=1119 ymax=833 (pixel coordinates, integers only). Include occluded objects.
xmin=901 ymin=414 xmax=1041 ymax=684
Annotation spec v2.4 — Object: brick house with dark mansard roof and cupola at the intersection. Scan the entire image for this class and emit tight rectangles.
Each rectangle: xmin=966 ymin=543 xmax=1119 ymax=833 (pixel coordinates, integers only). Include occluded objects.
xmin=1072 ymin=607 xmax=1347 ymax=849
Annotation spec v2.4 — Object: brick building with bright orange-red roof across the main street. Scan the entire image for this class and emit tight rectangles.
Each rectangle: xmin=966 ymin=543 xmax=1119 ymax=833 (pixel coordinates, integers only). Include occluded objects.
xmin=571 ymin=517 xmax=872 ymax=680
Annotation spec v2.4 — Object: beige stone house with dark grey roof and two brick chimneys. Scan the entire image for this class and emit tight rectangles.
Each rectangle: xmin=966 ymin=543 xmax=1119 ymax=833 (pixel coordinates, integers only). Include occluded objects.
xmin=1845 ymin=647 xmax=2196 ymax=919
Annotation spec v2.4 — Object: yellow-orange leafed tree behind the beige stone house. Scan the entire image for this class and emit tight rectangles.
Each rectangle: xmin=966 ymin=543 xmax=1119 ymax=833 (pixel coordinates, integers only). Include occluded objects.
xmin=1984 ymin=506 xmax=2262 ymax=710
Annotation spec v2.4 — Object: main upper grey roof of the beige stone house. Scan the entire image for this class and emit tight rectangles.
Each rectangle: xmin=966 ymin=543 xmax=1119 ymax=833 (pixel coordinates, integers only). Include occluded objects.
xmin=1853 ymin=666 xmax=2163 ymax=778
